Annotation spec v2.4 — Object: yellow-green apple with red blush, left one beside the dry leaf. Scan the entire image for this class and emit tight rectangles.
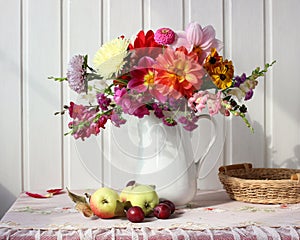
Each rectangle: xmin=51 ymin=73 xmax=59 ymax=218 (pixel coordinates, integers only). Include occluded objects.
xmin=90 ymin=187 xmax=120 ymax=218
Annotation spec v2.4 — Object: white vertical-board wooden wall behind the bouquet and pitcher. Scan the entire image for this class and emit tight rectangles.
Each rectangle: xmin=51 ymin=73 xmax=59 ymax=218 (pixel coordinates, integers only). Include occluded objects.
xmin=0 ymin=0 xmax=300 ymax=217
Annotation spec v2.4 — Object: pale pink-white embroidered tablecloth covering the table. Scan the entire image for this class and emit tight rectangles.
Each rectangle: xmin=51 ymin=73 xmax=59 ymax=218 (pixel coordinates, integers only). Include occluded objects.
xmin=0 ymin=190 xmax=300 ymax=240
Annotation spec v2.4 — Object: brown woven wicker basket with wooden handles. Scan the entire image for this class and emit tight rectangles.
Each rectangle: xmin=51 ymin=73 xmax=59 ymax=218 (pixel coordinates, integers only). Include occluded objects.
xmin=219 ymin=163 xmax=300 ymax=204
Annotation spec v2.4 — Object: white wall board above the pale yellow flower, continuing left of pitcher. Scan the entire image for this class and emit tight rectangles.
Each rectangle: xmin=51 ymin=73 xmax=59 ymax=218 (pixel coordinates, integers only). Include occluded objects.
xmin=103 ymin=0 xmax=144 ymax=188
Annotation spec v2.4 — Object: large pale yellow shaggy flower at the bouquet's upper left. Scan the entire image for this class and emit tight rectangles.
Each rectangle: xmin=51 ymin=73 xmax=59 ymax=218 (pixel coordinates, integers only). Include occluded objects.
xmin=94 ymin=38 xmax=129 ymax=78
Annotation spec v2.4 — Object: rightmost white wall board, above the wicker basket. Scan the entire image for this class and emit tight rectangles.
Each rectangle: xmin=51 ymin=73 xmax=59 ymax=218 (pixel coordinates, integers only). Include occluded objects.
xmin=267 ymin=0 xmax=300 ymax=168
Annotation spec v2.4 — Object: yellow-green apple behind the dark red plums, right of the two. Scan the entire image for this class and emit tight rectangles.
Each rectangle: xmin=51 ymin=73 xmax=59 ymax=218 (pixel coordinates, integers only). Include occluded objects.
xmin=120 ymin=184 xmax=159 ymax=216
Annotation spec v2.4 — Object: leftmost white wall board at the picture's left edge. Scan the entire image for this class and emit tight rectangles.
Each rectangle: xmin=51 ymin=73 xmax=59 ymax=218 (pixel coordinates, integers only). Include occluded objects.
xmin=0 ymin=0 xmax=22 ymax=218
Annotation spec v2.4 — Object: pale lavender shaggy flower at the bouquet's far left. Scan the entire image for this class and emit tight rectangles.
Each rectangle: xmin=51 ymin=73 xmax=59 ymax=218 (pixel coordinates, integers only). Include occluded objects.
xmin=67 ymin=55 xmax=86 ymax=93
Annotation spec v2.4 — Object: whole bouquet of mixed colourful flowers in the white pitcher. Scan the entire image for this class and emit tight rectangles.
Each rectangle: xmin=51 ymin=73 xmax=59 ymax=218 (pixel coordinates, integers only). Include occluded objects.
xmin=51 ymin=22 xmax=274 ymax=140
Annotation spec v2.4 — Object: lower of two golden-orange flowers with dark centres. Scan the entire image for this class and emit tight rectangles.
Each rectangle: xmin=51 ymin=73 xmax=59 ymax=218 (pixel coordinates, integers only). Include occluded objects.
xmin=210 ymin=60 xmax=234 ymax=89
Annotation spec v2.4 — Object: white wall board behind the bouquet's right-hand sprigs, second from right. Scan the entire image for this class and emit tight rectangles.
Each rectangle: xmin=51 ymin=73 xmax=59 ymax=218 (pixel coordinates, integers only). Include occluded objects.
xmin=224 ymin=0 xmax=265 ymax=166
